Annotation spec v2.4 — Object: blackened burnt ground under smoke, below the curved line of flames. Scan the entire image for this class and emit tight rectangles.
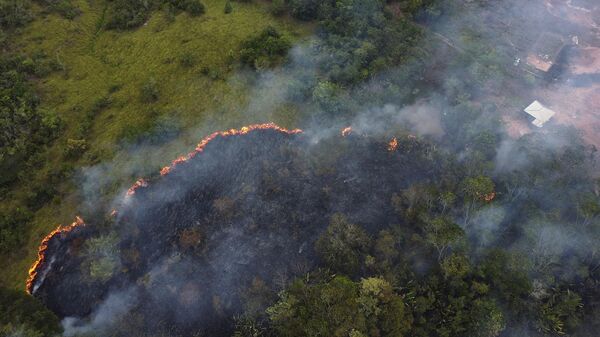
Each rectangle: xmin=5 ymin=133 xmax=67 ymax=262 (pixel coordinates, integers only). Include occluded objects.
xmin=35 ymin=130 xmax=440 ymax=336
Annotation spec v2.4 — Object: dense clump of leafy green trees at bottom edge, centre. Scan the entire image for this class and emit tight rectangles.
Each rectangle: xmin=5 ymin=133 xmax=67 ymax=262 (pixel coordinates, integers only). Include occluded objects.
xmin=267 ymin=276 xmax=412 ymax=337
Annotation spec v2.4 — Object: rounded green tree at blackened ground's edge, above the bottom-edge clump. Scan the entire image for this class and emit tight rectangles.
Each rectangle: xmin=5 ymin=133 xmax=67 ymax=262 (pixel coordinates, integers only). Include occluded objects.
xmin=315 ymin=213 xmax=371 ymax=275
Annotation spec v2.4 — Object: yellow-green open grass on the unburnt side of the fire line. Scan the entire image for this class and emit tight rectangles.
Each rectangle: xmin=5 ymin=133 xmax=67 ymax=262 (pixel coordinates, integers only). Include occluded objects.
xmin=0 ymin=0 xmax=312 ymax=289
